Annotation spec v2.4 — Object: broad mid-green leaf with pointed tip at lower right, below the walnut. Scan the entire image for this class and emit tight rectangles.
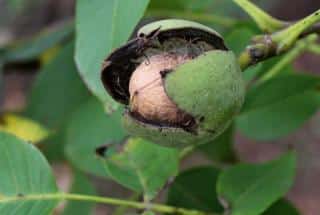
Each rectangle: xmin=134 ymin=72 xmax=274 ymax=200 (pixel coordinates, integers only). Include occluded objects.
xmin=217 ymin=153 xmax=296 ymax=215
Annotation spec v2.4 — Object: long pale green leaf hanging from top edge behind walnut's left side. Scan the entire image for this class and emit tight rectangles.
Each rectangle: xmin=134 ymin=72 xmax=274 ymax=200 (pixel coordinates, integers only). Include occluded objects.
xmin=75 ymin=0 xmax=149 ymax=108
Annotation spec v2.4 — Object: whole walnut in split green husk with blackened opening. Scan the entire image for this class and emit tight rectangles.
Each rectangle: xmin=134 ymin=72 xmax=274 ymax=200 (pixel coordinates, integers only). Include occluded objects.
xmin=102 ymin=19 xmax=245 ymax=147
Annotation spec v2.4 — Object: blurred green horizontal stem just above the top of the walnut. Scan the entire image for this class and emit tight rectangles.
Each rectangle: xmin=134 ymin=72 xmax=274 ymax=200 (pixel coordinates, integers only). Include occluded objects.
xmin=145 ymin=10 xmax=237 ymax=27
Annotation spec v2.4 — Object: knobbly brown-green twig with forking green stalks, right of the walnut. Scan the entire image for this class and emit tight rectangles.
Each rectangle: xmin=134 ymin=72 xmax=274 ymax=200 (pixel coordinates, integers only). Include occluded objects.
xmin=233 ymin=0 xmax=320 ymax=69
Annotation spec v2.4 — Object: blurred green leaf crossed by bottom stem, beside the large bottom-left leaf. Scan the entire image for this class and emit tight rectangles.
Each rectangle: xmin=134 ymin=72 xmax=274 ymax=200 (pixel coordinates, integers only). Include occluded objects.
xmin=62 ymin=171 xmax=96 ymax=215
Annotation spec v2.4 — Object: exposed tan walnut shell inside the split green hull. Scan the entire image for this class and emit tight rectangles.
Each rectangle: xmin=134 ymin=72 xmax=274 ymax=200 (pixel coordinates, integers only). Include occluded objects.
xmin=129 ymin=53 xmax=191 ymax=124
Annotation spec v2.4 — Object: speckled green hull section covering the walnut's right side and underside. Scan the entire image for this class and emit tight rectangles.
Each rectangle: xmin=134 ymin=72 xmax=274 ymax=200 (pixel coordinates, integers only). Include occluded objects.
xmin=123 ymin=50 xmax=245 ymax=147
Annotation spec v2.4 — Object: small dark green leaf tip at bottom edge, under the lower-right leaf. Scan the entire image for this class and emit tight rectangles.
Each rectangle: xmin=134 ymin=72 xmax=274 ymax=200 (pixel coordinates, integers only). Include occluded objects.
xmin=263 ymin=199 xmax=300 ymax=215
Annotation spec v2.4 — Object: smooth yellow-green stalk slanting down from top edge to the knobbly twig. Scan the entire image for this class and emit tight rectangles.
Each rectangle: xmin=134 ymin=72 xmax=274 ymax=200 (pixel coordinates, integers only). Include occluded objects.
xmin=233 ymin=0 xmax=286 ymax=33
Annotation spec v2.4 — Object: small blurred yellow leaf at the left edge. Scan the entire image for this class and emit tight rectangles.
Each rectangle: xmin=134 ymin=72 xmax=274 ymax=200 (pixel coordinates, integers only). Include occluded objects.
xmin=0 ymin=113 xmax=50 ymax=143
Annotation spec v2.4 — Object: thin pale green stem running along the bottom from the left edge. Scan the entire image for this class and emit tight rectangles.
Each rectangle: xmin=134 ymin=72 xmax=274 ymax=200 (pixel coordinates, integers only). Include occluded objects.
xmin=0 ymin=193 xmax=218 ymax=215
